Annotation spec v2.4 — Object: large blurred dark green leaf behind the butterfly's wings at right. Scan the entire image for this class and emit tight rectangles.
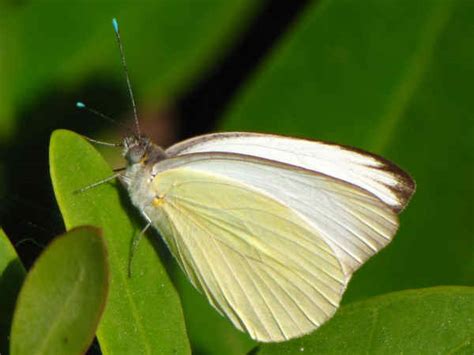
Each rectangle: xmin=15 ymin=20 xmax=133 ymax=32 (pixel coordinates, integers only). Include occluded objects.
xmin=221 ymin=0 xmax=474 ymax=301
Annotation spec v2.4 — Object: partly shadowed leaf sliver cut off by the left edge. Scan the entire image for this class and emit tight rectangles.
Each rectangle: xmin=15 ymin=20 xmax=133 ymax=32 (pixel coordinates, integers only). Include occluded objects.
xmin=0 ymin=228 xmax=26 ymax=354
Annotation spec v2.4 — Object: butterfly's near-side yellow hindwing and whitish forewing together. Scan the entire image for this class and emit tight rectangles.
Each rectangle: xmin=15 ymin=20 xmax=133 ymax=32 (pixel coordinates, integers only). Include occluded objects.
xmin=143 ymin=153 xmax=404 ymax=341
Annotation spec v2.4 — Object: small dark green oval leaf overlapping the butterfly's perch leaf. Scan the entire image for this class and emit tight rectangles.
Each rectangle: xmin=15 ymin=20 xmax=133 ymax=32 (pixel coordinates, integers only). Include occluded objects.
xmin=10 ymin=227 xmax=109 ymax=355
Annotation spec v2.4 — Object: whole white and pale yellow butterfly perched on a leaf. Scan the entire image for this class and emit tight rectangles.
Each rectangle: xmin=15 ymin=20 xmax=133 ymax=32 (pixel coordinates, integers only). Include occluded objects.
xmin=78 ymin=20 xmax=415 ymax=342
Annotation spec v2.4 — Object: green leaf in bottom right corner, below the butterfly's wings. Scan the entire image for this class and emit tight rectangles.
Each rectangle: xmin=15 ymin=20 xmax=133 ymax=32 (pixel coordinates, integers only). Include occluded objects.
xmin=258 ymin=286 xmax=474 ymax=355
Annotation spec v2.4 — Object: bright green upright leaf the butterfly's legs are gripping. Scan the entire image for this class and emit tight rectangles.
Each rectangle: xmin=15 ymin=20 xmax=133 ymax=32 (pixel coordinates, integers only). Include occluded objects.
xmin=50 ymin=130 xmax=189 ymax=354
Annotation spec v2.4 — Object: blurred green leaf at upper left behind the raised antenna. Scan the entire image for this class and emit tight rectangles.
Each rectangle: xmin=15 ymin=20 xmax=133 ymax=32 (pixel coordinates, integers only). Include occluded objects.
xmin=0 ymin=0 xmax=257 ymax=140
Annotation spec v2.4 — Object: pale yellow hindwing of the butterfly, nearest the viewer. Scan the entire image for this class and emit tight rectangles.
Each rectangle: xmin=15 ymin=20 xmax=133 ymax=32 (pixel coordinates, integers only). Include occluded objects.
xmin=145 ymin=162 xmax=348 ymax=342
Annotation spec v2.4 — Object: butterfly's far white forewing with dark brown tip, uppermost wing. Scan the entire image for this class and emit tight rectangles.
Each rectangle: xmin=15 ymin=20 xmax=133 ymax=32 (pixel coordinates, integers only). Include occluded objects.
xmin=166 ymin=132 xmax=415 ymax=212
